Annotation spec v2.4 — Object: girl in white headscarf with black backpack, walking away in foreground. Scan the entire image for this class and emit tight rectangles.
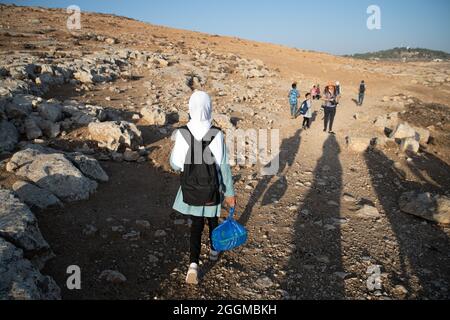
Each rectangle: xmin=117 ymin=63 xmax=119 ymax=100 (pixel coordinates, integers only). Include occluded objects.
xmin=170 ymin=91 xmax=236 ymax=285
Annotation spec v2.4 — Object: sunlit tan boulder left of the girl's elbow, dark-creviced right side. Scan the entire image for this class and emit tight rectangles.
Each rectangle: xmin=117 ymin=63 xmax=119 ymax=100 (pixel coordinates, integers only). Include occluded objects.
xmin=88 ymin=121 xmax=142 ymax=152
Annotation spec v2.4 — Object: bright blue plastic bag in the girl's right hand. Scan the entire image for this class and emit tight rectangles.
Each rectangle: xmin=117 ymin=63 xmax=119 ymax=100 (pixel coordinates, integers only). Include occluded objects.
xmin=212 ymin=208 xmax=248 ymax=252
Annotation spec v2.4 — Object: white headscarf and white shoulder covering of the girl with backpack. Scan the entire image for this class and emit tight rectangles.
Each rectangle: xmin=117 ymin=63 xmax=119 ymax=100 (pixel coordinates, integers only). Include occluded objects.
xmin=170 ymin=91 xmax=225 ymax=170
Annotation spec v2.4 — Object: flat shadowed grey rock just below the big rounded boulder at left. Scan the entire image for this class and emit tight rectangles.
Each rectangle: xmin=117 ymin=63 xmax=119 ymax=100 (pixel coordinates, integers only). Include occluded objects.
xmin=13 ymin=181 xmax=62 ymax=209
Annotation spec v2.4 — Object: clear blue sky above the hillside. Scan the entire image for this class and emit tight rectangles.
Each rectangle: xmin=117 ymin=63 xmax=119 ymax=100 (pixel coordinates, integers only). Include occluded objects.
xmin=0 ymin=0 xmax=450 ymax=54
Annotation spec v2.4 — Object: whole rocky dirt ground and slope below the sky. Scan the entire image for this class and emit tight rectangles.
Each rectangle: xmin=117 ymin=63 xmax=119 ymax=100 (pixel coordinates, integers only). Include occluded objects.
xmin=0 ymin=5 xmax=450 ymax=299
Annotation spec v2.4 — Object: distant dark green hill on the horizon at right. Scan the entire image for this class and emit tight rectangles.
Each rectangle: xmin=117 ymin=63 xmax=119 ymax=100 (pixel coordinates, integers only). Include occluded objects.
xmin=346 ymin=47 xmax=450 ymax=61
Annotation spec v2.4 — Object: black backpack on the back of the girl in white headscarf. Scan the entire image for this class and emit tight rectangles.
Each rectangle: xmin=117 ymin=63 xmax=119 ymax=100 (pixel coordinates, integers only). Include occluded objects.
xmin=180 ymin=126 xmax=222 ymax=207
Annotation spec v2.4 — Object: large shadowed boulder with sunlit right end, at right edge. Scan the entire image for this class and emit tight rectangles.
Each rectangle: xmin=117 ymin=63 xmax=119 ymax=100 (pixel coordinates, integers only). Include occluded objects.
xmin=399 ymin=191 xmax=450 ymax=225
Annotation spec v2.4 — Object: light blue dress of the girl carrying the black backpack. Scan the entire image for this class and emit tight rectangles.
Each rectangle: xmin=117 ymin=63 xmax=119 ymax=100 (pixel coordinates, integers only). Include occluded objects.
xmin=170 ymin=136 xmax=235 ymax=218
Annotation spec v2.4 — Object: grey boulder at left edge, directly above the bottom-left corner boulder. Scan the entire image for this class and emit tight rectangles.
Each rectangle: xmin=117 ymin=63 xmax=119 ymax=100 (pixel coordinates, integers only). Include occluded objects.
xmin=0 ymin=189 xmax=50 ymax=256
